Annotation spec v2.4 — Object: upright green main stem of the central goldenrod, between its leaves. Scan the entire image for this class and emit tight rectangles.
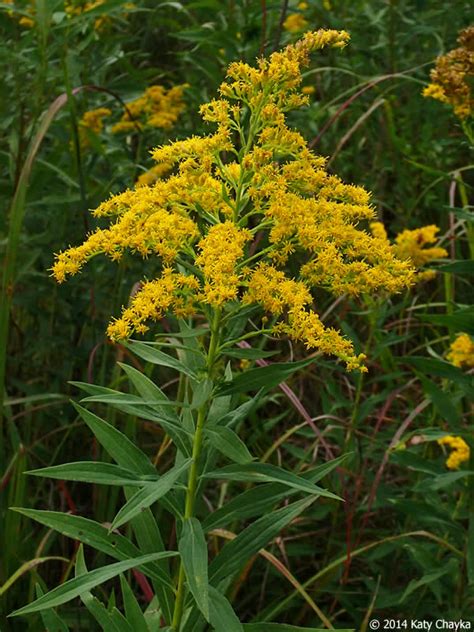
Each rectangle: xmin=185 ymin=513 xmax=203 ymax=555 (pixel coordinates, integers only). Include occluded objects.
xmin=171 ymin=309 xmax=221 ymax=630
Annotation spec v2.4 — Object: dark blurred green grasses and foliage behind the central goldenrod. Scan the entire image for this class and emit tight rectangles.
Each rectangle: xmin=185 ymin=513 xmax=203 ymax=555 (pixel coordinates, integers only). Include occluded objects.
xmin=0 ymin=0 xmax=474 ymax=631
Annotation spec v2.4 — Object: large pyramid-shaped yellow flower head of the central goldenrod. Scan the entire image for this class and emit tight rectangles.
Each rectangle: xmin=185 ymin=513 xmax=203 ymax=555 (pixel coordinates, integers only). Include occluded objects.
xmin=53 ymin=30 xmax=414 ymax=370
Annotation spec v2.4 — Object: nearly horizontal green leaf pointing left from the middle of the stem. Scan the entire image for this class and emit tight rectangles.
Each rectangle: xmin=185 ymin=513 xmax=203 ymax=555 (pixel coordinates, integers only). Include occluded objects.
xmin=25 ymin=461 xmax=154 ymax=487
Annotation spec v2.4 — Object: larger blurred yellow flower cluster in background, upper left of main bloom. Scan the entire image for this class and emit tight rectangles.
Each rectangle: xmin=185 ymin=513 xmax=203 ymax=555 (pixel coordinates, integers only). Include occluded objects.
xmin=112 ymin=84 xmax=187 ymax=134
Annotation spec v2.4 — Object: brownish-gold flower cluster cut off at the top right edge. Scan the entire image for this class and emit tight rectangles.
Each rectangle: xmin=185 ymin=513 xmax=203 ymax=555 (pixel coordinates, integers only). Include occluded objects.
xmin=423 ymin=26 xmax=474 ymax=119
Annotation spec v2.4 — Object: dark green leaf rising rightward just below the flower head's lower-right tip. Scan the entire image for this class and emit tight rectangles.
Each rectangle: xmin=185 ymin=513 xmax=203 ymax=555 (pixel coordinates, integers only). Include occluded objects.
xmin=218 ymin=358 xmax=314 ymax=395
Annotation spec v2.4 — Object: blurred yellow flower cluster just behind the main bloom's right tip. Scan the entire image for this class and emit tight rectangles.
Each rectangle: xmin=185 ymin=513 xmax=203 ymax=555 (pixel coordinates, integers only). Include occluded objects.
xmin=369 ymin=222 xmax=448 ymax=281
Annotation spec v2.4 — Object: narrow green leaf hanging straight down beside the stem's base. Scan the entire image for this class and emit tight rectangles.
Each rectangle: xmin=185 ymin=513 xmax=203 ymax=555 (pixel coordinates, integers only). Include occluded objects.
xmin=178 ymin=518 xmax=209 ymax=621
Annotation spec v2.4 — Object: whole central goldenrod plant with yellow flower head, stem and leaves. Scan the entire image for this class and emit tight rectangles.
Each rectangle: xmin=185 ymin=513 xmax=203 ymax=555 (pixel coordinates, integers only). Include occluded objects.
xmin=15 ymin=30 xmax=414 ymax=632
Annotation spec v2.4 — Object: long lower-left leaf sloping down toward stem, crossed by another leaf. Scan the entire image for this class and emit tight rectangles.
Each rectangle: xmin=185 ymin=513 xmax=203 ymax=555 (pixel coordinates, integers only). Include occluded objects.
xmin=10 ymin=507 xmax=174 ymax=588
